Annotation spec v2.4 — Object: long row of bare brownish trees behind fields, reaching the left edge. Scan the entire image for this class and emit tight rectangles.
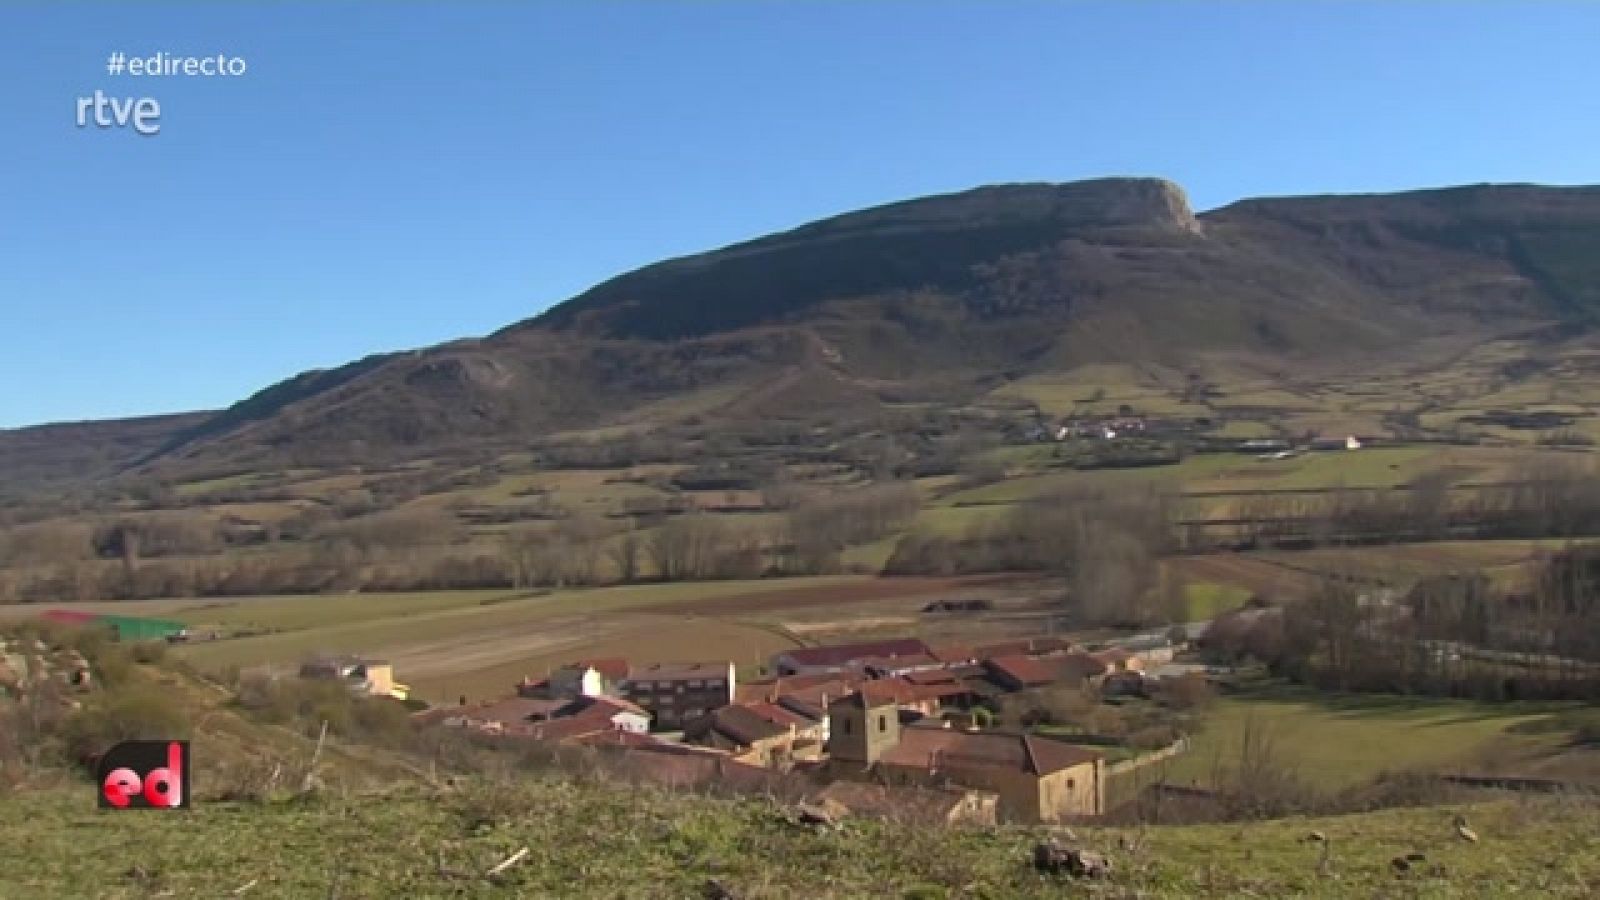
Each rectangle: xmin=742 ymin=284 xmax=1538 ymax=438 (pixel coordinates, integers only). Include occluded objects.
xmin=0 ymin=484 xmax=918 ymax=602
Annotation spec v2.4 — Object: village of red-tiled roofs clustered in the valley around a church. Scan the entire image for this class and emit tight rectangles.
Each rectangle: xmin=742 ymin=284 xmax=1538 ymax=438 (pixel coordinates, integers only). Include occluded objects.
xmin=288 ymin=626 xmax=1206 ymax=825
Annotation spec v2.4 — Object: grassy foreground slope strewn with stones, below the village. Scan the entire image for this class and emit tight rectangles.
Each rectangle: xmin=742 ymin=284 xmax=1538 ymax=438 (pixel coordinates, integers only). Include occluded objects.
xmin=0 ymin=777 xmax=1600 ymax=898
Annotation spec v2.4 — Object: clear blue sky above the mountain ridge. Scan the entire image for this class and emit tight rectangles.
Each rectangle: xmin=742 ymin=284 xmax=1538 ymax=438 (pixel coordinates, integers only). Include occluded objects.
xmin=0 ymin=0 xmax=1600 ymax=428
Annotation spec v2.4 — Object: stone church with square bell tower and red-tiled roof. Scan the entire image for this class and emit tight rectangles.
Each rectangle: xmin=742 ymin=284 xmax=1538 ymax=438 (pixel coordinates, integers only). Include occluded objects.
xmin=827 ymin=693 xmax=1106 ymax=822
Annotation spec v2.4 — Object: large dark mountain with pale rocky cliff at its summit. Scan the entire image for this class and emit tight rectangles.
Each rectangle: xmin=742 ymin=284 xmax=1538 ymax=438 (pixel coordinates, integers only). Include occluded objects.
xmin=18 ymin=179 xmax=1600 ymax=483
